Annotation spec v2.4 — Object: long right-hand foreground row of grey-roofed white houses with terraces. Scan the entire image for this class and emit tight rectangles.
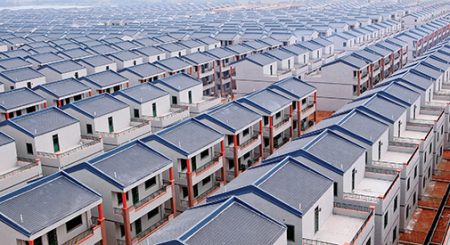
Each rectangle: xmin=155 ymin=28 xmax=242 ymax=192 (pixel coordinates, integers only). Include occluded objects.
xmin=140 ymin=37 xmax=450 ymax=244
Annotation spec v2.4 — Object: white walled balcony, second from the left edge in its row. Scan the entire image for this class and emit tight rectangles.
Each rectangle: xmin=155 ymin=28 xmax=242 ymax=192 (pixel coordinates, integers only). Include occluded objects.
xmin=36 ymin=136 xmax=103 ymax=172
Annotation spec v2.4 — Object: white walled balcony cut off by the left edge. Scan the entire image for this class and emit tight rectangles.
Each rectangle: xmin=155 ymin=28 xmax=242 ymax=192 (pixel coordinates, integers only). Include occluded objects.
xmin=0 ymin=158 xmax=42 ymax=192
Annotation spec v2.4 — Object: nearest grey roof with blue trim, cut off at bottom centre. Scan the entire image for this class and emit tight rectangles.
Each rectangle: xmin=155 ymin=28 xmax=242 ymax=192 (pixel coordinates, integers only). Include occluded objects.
xmin=141 ymin=197 xmax=287 ymax=245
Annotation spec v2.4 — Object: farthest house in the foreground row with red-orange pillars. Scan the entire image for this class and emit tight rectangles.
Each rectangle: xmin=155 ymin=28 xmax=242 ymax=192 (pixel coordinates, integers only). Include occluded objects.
xmin=269 ymin=77 xmax=317 ymax=137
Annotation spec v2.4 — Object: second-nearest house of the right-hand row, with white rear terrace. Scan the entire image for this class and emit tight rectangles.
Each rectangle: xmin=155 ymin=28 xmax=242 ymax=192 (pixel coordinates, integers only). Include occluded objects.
xmin=208 ymin=157 xmax=375 ymax=244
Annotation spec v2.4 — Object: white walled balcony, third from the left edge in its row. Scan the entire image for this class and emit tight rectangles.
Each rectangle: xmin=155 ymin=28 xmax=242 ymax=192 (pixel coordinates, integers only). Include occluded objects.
xmin=97 ymin=119 xmax=151 ymax=150
